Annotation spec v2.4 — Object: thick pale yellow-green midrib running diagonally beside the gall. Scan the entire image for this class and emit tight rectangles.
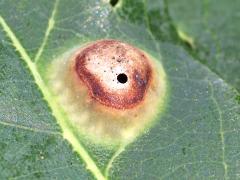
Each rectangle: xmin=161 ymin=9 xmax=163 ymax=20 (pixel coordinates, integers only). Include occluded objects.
xmin=0 ymin=16 xmax=105 ymax=180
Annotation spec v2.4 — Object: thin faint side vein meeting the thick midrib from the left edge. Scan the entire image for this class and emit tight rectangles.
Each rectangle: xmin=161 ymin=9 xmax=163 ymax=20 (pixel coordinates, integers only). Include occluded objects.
xmin=0 ymin=121 xmax=60 ymax=135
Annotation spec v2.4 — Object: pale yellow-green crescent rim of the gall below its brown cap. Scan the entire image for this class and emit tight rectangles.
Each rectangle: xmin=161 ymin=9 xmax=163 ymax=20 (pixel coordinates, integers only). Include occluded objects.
xmin=49 ymin=43 xmax=166 ymax=144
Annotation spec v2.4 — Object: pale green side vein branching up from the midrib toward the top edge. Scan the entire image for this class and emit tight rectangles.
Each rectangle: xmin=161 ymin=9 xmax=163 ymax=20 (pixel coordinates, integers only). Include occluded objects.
xmin=34 ymin=0 xmax=59 ymax=62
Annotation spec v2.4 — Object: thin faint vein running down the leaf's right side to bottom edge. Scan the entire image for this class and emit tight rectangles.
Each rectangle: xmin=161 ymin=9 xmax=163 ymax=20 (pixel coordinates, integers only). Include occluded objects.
xmin=209 ymin=81 xmax=228 ymax=179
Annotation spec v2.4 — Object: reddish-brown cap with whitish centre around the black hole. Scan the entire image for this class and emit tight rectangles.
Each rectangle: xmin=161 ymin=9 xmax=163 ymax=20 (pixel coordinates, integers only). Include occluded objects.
xmin=73 ymin=40 xmax=152 ymax=109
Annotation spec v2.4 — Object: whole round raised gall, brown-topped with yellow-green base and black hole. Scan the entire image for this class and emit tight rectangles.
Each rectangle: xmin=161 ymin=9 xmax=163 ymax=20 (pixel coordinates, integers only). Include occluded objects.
xmin=49 ymin=40 xmax=166 ymax=144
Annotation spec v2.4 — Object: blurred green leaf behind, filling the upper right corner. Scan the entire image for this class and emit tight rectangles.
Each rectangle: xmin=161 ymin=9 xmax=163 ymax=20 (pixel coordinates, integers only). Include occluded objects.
xmin=168 ymin=0 xmax=240 ymax=91
